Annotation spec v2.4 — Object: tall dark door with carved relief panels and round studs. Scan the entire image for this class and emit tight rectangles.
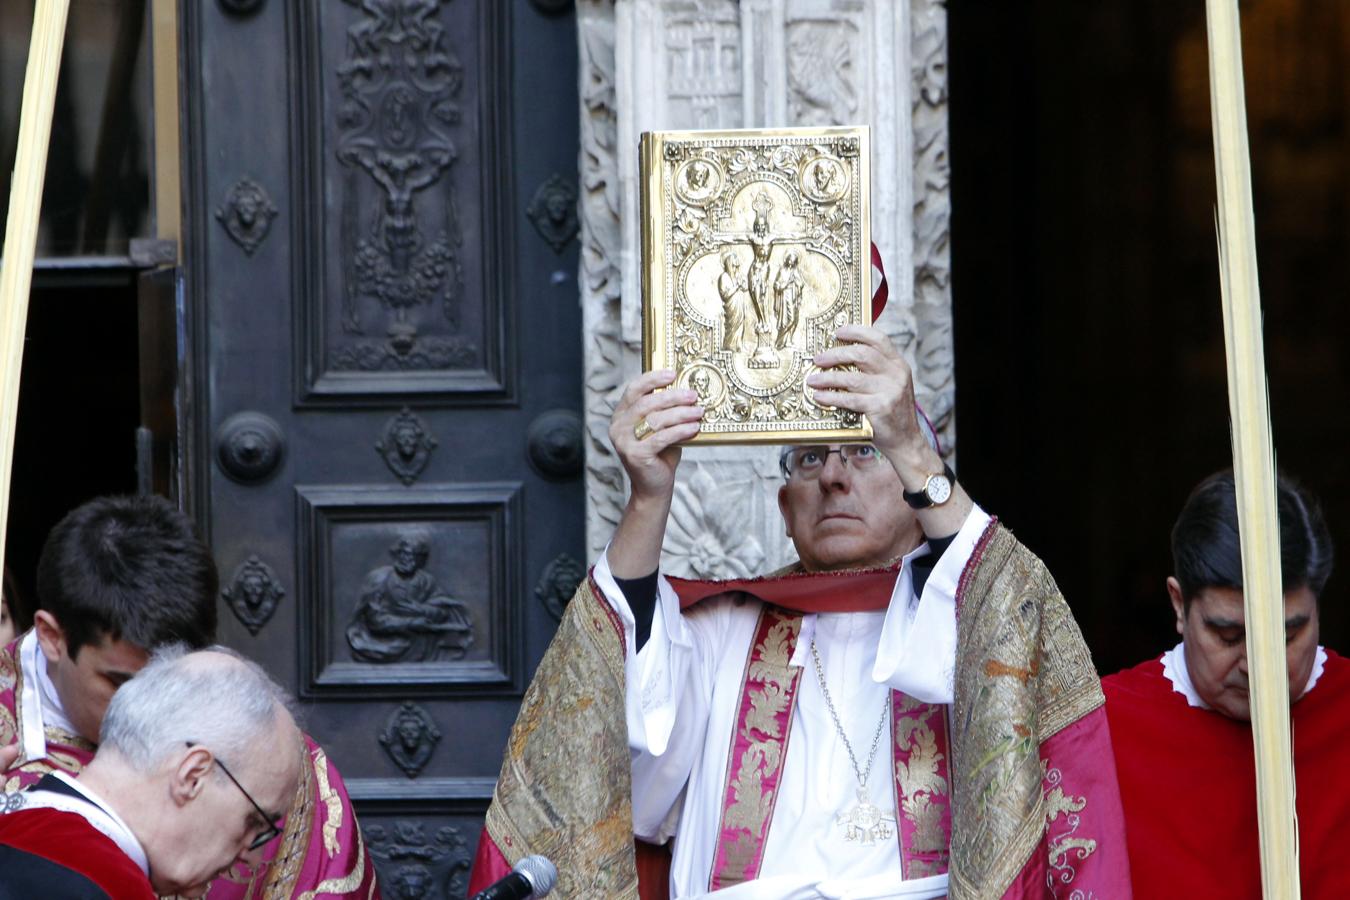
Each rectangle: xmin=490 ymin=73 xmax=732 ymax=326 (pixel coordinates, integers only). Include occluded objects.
xmin=182 ymin=0 xmax=585 ymax=897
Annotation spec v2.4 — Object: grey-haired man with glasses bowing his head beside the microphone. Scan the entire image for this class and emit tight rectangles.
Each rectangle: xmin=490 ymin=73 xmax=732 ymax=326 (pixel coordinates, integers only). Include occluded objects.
xmin=0 ymin=645 xmax=302 ymax=900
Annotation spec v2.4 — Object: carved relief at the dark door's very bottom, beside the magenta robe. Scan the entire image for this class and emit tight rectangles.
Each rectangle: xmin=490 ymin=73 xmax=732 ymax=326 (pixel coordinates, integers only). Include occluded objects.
xmin=362 ymin=819 xmax=471 ymax=900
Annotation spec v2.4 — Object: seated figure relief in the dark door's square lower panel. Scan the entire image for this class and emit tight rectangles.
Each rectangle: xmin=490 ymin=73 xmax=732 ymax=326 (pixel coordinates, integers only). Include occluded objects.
xmin=347 ymin=529 xmax=474 ymax=663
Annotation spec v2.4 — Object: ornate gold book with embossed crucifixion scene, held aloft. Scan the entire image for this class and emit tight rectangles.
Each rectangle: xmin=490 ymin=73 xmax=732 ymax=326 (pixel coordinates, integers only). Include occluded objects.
xmin=640 ymin=127 xmax=872 ymax=444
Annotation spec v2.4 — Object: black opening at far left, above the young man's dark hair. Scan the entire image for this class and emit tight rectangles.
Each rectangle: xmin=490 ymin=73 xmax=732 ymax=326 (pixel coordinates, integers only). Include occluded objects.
xmin=5 ymin=270 xmax=139 ymax=598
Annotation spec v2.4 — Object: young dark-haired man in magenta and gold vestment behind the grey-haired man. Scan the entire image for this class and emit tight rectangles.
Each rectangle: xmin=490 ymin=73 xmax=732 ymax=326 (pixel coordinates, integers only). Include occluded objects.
xmin=0 ymin=497 xmax=378 ymax=900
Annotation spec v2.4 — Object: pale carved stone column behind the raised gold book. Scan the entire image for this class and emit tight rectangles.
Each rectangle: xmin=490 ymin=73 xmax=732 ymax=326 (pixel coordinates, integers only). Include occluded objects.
xmin=576 ymin=0 xmax=954 ymax=578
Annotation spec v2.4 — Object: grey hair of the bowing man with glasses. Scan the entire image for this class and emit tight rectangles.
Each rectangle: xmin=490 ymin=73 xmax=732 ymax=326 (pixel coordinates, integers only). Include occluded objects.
xmin=99 ymin=644 xmax=292 ymax=772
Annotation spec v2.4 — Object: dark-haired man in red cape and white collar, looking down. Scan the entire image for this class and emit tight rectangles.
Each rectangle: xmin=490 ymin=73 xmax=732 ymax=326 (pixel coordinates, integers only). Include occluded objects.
xmin=1102 ymin=472 xmax=1350 ymax=900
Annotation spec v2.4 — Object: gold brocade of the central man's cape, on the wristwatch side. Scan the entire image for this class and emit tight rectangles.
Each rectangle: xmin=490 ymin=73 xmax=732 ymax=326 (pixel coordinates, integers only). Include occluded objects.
xmin=949 ymin=522 xmax=1104 ymax=900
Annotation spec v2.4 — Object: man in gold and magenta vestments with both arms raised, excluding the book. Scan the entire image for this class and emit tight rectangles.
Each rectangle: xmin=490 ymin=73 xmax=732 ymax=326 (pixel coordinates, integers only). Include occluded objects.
xmin=474 ymin=325 xmax=1129 ymax=900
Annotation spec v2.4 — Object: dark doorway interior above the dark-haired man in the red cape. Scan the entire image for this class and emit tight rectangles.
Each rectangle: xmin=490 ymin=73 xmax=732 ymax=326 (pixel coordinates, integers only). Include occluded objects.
xmin=948 ymin=0 xmax=1350 ymax=672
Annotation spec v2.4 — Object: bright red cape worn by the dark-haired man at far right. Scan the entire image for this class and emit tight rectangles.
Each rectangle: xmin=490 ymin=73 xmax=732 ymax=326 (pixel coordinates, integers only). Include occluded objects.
xmin=1102 ymin=650 xmax=1350 ymax=900
